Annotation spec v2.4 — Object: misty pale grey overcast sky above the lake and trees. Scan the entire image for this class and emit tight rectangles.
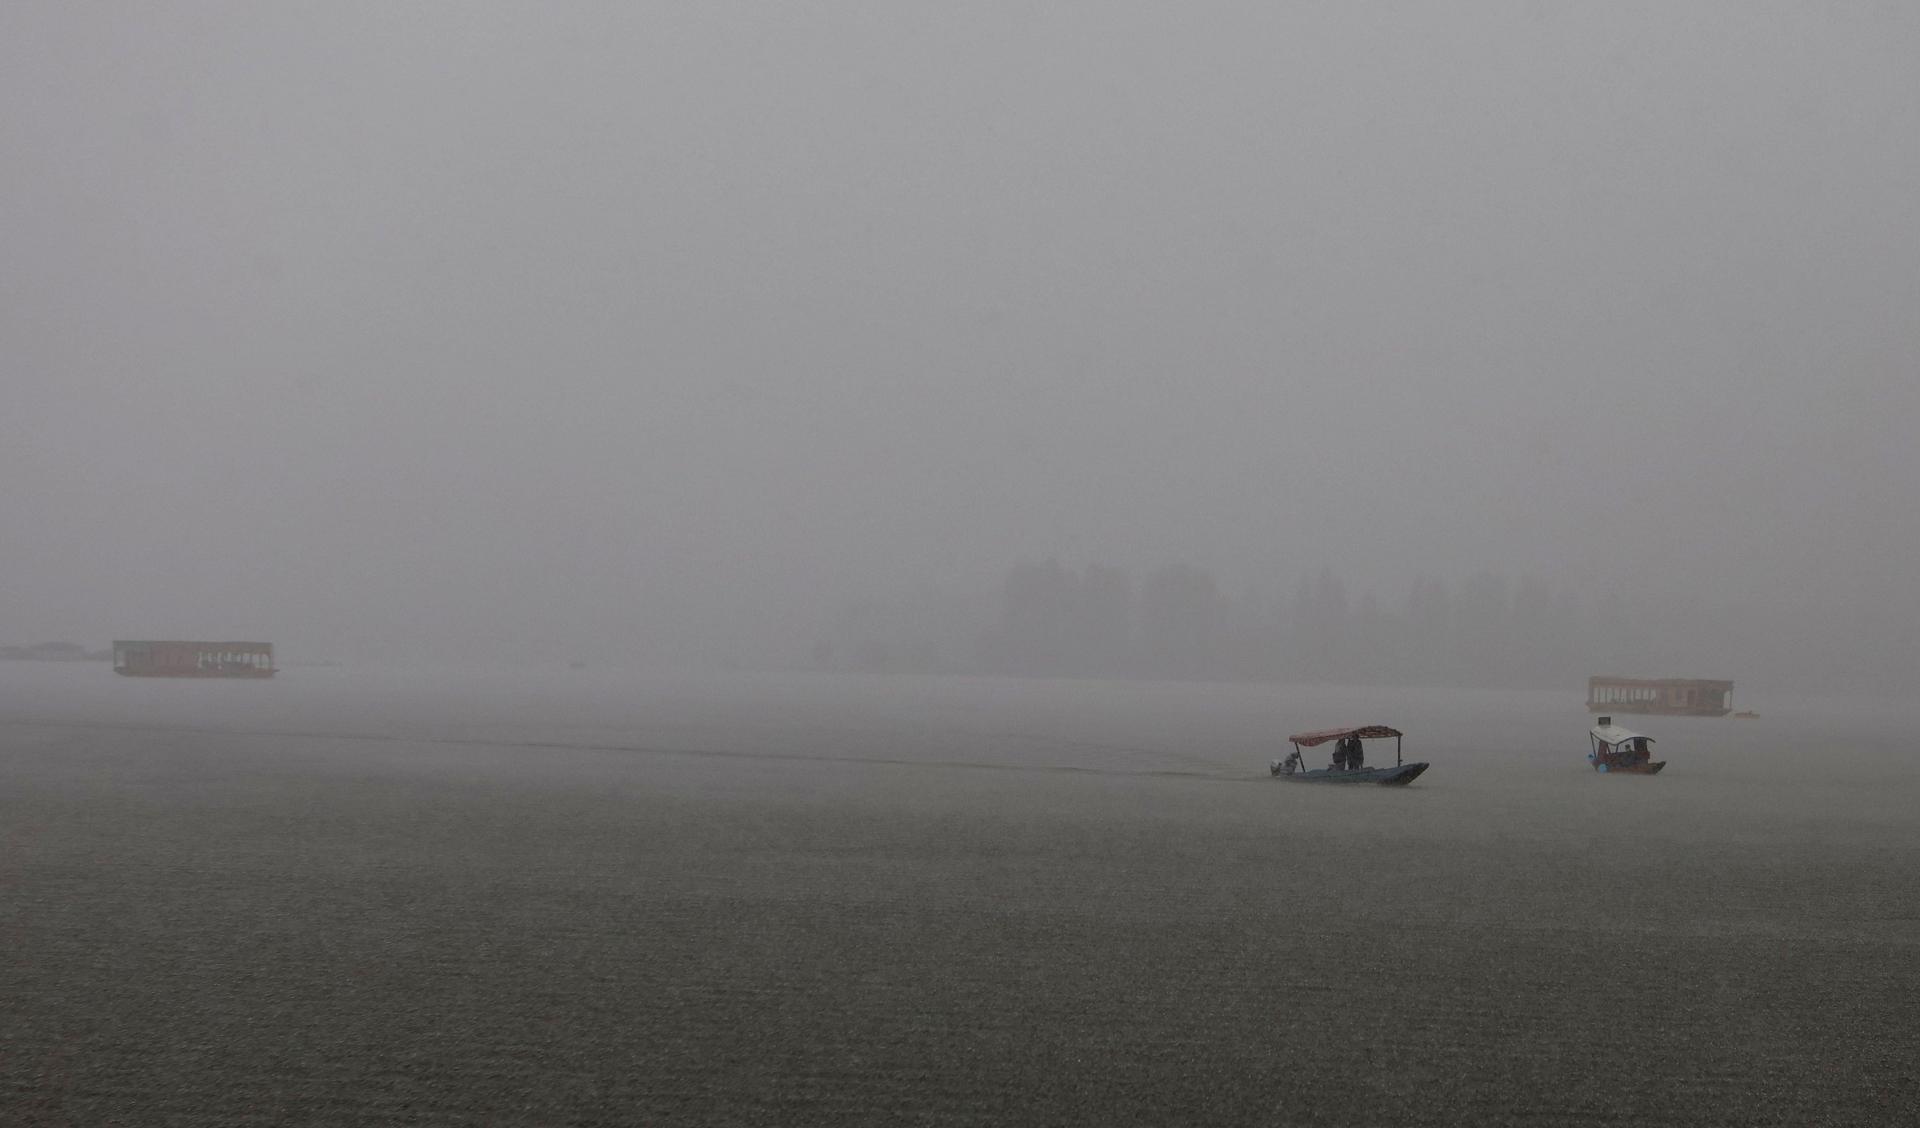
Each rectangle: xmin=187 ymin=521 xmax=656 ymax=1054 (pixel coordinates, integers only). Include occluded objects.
xmin=0 ymin=0 xmax=1920 ymax=659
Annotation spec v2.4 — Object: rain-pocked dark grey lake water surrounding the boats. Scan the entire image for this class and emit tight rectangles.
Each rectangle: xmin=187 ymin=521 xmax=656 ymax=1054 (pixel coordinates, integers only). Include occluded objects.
xmin=0 ymin=662 xmax=1920 ymax=1124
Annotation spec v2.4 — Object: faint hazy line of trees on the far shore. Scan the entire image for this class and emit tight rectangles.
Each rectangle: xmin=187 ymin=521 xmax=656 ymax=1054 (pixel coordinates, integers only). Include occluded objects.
xmin=812 ymin=560 xmax=1758 ymax=689
